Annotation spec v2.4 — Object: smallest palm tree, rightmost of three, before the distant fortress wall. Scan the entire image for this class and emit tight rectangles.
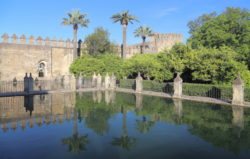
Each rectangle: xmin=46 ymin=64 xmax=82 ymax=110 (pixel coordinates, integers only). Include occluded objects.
xmin=134 ymin=26 xmax=153 ymax=54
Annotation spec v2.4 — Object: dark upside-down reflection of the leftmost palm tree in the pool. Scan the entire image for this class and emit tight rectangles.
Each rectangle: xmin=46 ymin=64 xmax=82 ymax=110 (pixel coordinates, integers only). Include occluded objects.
xmin=62 ymin=110 xmax=89 ymax=153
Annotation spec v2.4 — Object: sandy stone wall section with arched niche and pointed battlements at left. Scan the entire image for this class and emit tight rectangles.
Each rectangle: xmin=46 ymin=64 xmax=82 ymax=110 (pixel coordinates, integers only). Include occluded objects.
xmin=0 ymin=34 xmax=73 ymax=81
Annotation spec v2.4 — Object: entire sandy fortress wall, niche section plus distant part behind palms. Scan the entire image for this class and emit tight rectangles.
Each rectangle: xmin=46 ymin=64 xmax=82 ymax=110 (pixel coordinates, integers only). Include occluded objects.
xmin=0 ymin=33 xmax=183 ymax=81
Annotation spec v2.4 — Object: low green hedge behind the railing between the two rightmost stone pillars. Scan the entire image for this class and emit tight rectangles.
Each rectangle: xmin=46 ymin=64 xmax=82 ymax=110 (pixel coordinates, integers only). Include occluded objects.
xmin=182 ymin=83 xmax=232 ymax=100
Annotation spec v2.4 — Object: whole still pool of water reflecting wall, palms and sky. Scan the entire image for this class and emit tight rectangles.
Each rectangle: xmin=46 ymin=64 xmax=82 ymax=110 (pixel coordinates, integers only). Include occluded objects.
xmin=0 ymin=91 xmax=250 ymax=159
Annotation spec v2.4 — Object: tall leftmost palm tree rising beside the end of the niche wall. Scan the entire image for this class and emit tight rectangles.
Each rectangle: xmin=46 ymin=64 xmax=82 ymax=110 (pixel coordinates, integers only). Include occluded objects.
xmin=62 ymin=10 xmax=89 ymax=59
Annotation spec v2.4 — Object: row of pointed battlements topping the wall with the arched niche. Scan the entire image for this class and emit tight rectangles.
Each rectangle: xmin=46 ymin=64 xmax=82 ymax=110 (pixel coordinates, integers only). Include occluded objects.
xmin=1 ymin=33 xmax=73 ymax=48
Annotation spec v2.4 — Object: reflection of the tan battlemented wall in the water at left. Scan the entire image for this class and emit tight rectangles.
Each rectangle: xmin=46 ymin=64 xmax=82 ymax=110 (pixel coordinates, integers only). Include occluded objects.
xmin=0 ymin=93 xmax=75 ymax=131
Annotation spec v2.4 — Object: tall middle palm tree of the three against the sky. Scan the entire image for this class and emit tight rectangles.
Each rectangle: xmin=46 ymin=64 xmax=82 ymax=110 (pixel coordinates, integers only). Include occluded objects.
xmin=111 ymin=11 xmax=138 ymax=58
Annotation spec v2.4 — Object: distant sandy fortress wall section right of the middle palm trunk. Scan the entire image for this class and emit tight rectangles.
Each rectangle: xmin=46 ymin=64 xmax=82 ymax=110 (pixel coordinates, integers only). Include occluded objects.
xmin=126 ymin=33 xmax=183 ymax=58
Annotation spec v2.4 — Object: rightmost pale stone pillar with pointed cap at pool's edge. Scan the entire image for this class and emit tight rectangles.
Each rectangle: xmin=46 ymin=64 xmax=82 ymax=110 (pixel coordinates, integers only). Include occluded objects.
xmin=232 ymin=75 xmax=244 ymax=105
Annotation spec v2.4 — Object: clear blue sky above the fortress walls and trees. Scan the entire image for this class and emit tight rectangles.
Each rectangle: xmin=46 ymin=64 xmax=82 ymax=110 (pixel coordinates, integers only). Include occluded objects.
xmin=0 ymin=0 xmax=250 ymax=44
